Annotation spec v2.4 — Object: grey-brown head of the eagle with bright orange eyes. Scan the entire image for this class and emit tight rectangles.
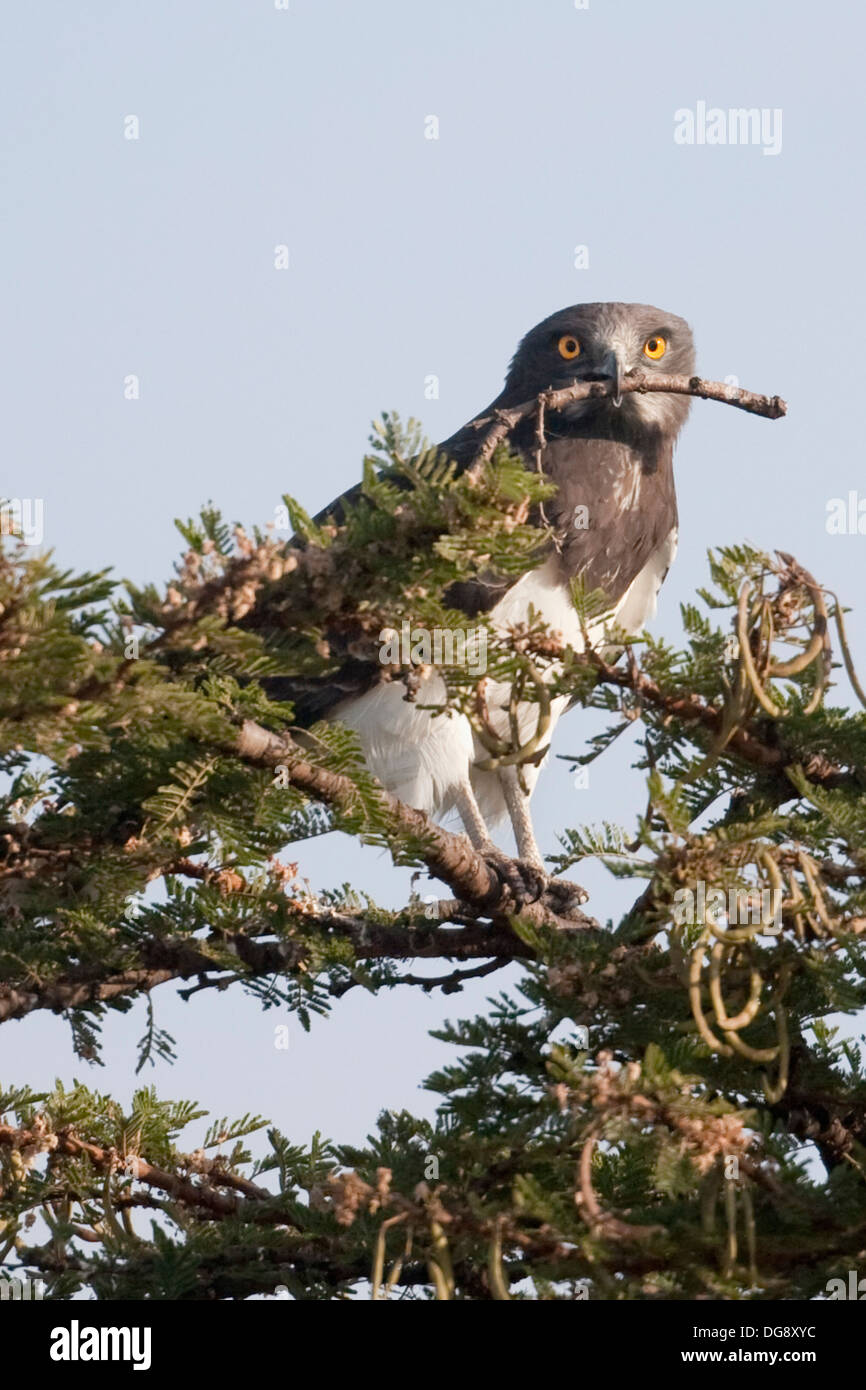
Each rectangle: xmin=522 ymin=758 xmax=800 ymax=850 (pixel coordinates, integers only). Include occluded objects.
xmin=503 ymin=303 xmax=695 ymax=434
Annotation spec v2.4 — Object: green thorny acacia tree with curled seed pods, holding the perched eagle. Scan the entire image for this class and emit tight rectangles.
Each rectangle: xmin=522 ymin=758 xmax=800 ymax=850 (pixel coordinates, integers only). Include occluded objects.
xmin=0 ymin=378 xmax=866 ymax=1300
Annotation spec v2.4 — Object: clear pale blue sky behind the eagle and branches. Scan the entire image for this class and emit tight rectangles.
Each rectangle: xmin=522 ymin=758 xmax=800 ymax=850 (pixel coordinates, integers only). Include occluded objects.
xmin=0 ymin=0 xmax=866 ymax=1140
